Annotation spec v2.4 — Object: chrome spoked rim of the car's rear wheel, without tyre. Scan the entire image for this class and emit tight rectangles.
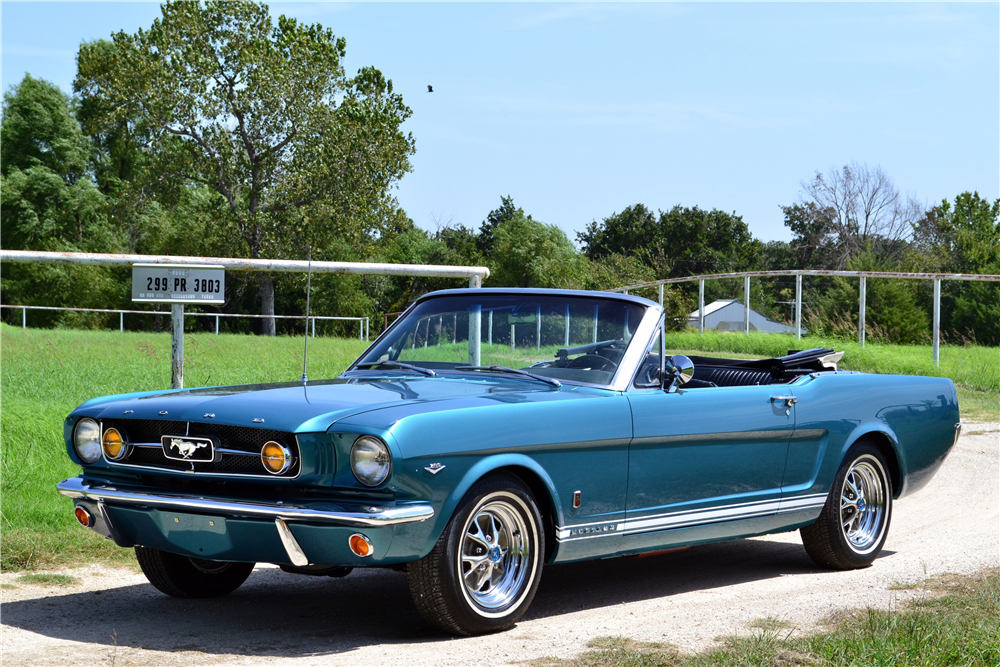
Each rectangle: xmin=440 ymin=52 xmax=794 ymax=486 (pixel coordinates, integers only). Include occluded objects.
xmin=840 ymin=456 xmax=887 ymax=554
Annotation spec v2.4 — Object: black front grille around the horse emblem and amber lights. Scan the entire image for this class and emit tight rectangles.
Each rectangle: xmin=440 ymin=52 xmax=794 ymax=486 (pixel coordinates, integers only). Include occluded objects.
xmin=101 ymin=419 xmax=301 ymax=478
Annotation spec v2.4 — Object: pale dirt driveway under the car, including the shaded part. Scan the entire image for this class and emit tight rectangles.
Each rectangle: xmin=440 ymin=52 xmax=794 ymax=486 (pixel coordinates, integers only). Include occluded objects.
xmin=0 ymin=424 xmax=1000 ymax=667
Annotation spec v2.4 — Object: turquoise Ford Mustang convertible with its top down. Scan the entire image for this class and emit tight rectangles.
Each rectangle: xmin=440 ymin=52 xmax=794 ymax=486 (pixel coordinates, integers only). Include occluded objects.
xmin=59 ymin=289 xmax=959 ymax=634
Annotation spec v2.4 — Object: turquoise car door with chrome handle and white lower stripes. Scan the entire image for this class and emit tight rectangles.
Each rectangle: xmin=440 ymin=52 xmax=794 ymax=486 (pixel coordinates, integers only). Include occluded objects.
xmin=624 ymin=385 xmax=795 ymax=551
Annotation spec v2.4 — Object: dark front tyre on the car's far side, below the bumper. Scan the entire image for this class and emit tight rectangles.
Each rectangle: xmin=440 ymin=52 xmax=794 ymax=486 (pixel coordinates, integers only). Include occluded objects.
xmin=135 ymin=546 xmax=254 ymax=598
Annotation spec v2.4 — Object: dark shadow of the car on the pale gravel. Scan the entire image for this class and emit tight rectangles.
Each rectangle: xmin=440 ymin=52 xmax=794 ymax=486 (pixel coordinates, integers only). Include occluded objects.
xmin=3 ymin=540 xmax=892 ymax=657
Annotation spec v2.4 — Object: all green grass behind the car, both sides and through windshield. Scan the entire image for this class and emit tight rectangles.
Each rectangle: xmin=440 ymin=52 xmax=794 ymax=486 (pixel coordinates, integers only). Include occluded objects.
xmin=0 ymin=325 xmax=1000 ymax=571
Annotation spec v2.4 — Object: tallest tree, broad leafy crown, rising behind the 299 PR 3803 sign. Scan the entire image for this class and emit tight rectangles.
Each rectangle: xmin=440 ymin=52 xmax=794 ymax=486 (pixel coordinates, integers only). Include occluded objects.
xmin=75 ymin=2 xmax=414 ymax=335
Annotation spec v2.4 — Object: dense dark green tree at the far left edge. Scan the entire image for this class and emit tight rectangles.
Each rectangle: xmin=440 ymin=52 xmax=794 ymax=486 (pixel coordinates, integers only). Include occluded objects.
xmin=0 ymin=74 xmax=122 ymax=325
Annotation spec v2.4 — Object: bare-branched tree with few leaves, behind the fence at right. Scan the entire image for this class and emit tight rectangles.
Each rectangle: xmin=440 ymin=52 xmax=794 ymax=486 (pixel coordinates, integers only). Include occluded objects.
xmin=796 ymin=162 xmax=923 ymax=269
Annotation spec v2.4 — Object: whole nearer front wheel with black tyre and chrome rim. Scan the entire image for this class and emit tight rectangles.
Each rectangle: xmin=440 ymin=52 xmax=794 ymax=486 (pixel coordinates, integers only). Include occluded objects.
xmin=408 ymin=475 xmax=545 ymax=635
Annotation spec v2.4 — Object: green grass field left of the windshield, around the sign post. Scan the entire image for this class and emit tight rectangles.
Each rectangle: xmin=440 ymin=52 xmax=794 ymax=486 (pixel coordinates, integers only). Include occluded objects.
xmin=0 ymin=325 xmax=366 ymax=571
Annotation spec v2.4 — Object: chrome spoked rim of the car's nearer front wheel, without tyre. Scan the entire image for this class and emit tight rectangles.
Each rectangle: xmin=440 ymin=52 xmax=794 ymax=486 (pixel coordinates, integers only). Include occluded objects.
xmin=458 ymin=491 xmax=534 ymax=616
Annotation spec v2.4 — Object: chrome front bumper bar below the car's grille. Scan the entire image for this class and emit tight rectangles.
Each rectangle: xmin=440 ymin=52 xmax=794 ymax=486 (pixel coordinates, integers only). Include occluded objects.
xmin=56 ymin=477 xmax=434 ymax=526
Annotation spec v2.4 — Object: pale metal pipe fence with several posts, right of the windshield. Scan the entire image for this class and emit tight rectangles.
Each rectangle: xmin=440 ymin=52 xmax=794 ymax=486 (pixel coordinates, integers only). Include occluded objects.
xmin=605 ymin=269 xmax=1000 ymax=366
